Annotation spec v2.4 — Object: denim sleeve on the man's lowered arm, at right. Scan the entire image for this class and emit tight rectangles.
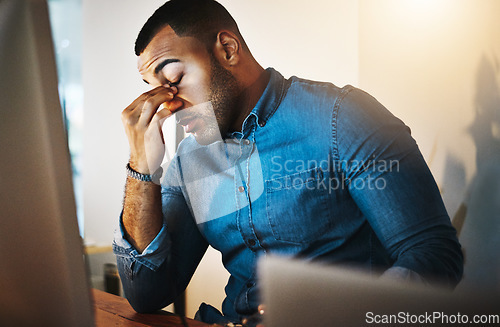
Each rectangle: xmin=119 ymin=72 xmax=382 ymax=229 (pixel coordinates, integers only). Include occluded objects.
xmin=336 ymin=88 xmax=463 ymax=287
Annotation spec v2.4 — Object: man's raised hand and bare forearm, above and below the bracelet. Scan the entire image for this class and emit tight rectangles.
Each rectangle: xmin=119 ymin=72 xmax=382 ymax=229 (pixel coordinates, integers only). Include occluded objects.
xmin=122 ymin=86 xmax=182 ymax=252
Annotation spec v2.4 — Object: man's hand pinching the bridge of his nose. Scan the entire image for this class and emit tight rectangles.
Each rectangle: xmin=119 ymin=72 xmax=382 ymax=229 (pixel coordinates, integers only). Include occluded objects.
xmin=122 ymin=86 xmax=183 ymax=174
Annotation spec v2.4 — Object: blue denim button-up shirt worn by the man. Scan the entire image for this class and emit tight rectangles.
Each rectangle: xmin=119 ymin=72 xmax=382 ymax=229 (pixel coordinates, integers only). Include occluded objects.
xmin=114 ymin=69 xmax=463 ymax=322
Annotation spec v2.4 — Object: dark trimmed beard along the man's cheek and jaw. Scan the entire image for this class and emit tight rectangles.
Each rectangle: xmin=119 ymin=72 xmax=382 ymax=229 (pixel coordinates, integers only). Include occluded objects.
xmin=191 ymin=55 xmax=240 ymax=145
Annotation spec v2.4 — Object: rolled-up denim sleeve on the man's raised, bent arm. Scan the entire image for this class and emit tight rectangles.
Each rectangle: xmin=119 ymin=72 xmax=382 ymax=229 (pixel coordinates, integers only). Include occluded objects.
xmin=113 ymin=158 xmax=208 ymax=313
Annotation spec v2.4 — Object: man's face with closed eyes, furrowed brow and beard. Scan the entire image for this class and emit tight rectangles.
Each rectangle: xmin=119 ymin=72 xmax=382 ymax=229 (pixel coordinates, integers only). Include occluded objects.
xmin=138 ymin=26 xmax=239 ymax=144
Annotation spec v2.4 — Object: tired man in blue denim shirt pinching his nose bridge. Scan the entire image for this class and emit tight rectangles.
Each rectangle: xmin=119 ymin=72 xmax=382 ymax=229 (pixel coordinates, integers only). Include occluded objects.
xmin=114 ymin=0 xmax=463 ymax=323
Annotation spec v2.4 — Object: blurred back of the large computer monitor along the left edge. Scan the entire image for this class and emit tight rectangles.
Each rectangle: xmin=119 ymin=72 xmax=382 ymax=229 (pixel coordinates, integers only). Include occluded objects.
xmin=0 ymin=0 xmax=94 ymax=326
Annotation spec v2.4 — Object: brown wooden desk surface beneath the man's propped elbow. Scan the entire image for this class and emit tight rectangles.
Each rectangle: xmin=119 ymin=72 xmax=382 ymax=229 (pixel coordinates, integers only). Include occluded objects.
xmin=92 ymin=289 xmax=217 ymax=327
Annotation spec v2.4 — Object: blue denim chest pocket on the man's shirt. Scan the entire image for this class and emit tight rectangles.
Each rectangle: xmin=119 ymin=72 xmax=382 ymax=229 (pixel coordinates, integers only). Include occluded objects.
xmin=266 ymin=168 xmax=331 ymax=243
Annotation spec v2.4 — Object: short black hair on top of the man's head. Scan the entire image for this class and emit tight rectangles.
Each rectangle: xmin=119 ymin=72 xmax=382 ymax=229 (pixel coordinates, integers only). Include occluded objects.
xmin=135 ymin=0 xmax=246 ymax=56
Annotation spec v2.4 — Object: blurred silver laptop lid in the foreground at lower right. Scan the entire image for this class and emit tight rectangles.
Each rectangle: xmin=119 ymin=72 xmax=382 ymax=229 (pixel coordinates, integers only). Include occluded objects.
xmin=259 ymin=257 xmax=500 ymax=327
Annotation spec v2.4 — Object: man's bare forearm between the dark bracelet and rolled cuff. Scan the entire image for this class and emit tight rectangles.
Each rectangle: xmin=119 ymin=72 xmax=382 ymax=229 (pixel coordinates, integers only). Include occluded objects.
xmin=122 ymin=177 xmax=163 ymax=252
